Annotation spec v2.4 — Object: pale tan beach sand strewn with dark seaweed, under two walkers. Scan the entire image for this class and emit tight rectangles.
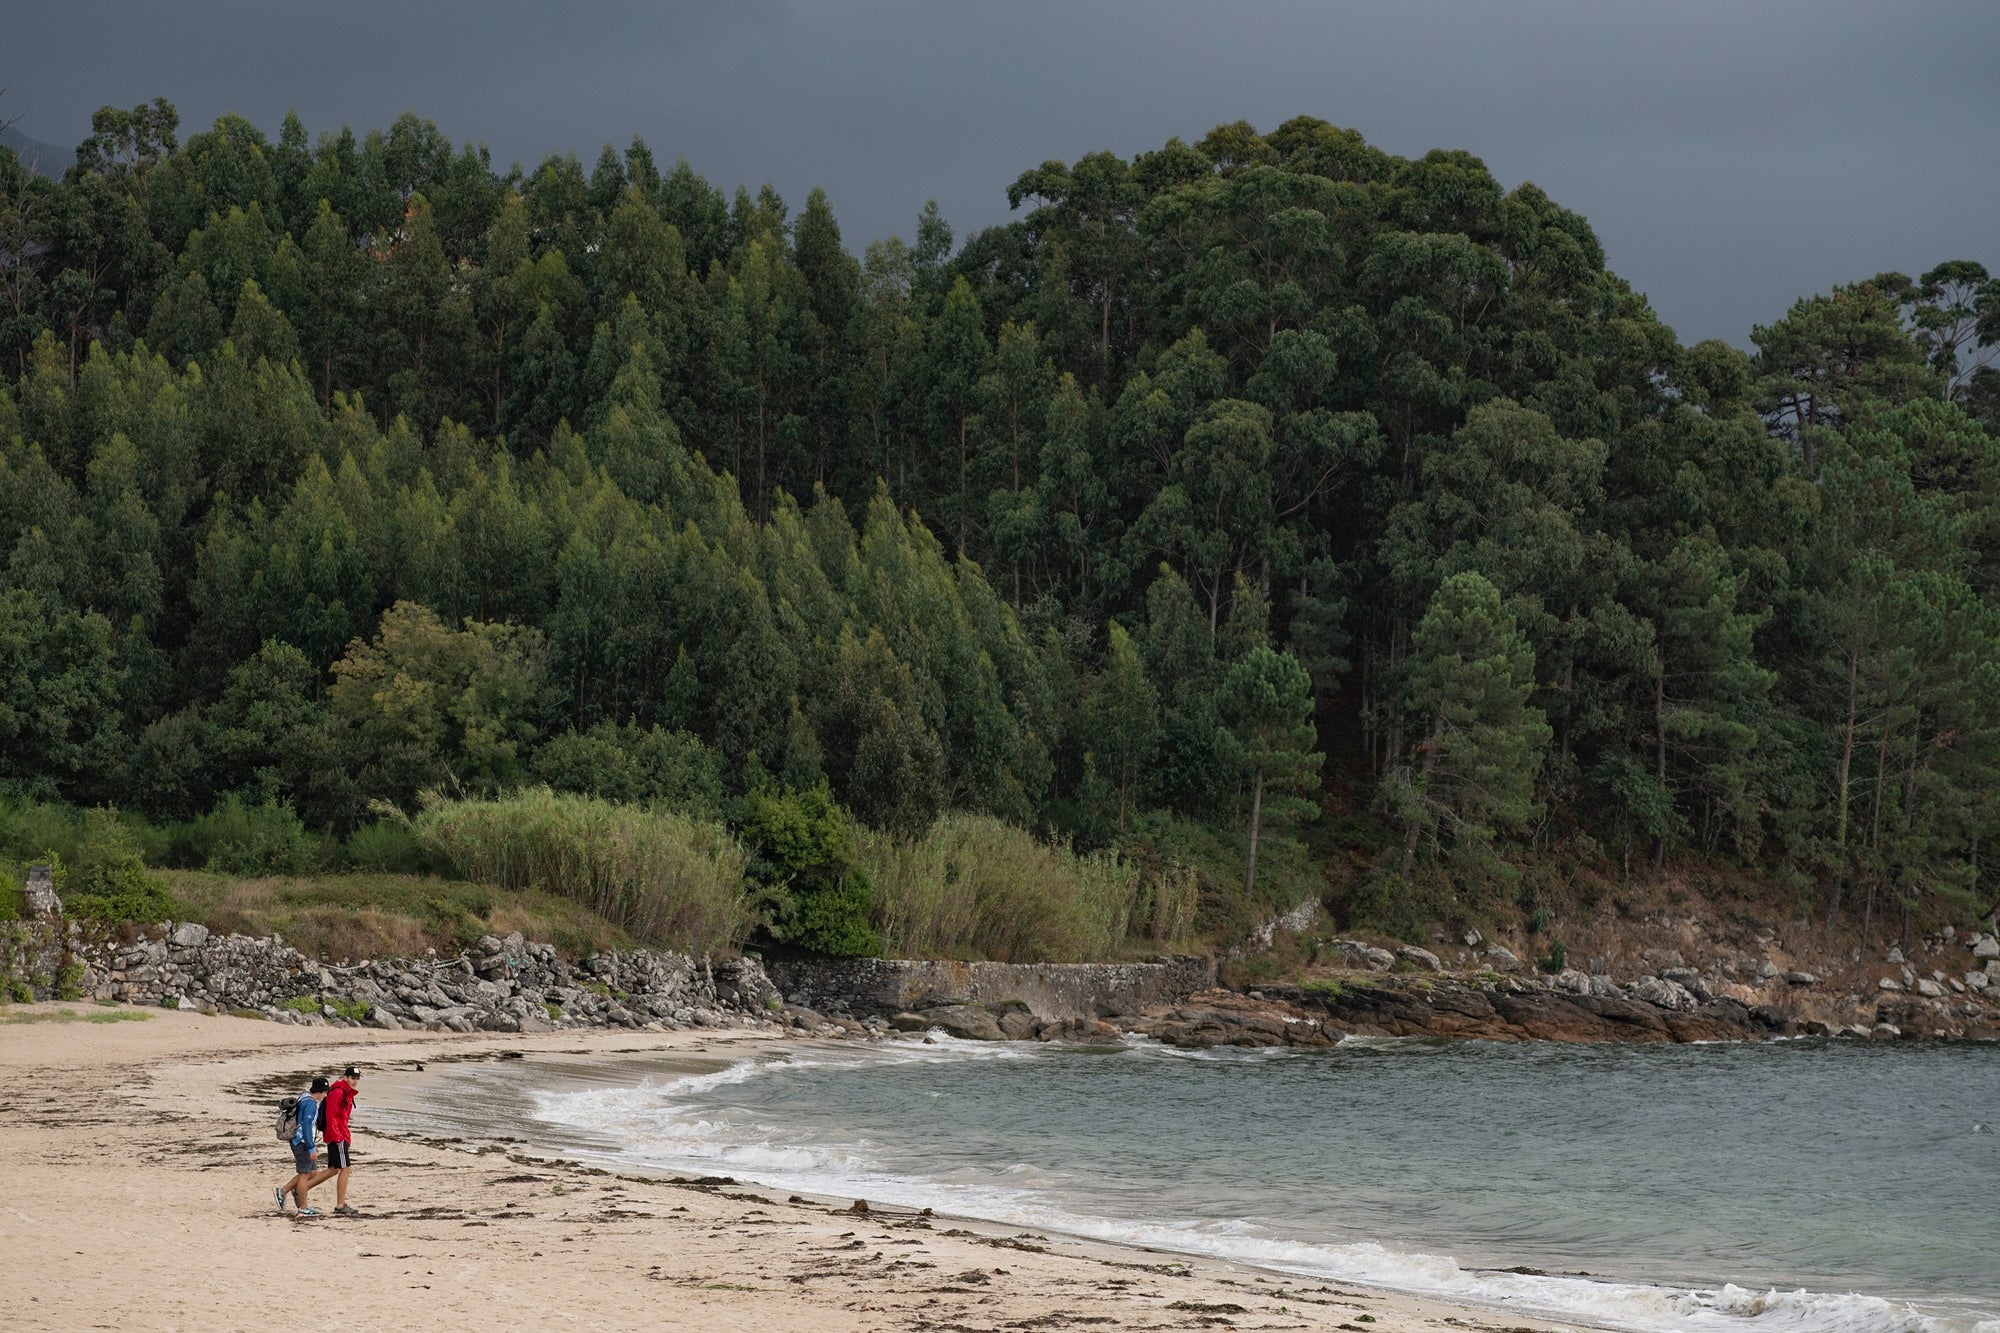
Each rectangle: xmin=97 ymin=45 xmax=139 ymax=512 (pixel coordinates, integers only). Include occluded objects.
xmin=0 ymin=1005 xmax=1572 ymax=1333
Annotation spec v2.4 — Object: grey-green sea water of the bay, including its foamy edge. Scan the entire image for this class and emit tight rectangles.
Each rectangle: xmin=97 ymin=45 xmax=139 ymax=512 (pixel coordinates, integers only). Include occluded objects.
xmin=376 ymin=1037 xmax=2000 ymax=1333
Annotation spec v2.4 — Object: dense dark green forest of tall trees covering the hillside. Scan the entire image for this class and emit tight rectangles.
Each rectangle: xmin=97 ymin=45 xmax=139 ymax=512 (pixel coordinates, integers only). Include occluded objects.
xmin=0 ymin=102 xmax=2000 ymax=956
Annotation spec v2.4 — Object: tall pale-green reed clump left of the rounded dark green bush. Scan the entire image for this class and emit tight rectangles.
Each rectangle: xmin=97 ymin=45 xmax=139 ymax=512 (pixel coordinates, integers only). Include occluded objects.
xmin=412 ymin=787 xmax=756 ymax=953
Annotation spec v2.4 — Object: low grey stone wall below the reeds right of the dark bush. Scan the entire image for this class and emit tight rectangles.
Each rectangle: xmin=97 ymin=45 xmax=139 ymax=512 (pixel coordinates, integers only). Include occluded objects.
xmin=766 ymin=944 xmax=1216 ymax=1023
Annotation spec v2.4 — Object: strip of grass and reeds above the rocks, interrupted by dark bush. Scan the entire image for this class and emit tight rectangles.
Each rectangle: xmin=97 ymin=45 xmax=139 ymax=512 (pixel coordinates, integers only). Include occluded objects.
xmin=11 ymin=789 xmax=1216 ymax=963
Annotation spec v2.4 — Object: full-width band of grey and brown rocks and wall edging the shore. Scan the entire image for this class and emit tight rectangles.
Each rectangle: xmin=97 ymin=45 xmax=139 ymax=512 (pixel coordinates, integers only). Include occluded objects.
xmin=0 ymin=904 xmax=2000 ymax=1049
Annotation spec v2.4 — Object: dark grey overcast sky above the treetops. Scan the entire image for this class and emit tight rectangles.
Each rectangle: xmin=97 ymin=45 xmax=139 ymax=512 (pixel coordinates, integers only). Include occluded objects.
xmin=0 ymin=0 xmax=2000 ymax=342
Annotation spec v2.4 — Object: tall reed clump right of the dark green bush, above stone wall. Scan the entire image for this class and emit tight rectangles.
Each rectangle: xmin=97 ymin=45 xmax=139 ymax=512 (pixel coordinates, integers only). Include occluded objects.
xmin=858 ymin=813 xmax=1194 ymax=963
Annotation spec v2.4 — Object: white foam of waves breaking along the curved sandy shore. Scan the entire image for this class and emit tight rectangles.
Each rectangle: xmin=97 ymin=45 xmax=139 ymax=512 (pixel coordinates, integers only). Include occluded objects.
xmin=534 ymin=1039 xmax=2000 ymax=1333
